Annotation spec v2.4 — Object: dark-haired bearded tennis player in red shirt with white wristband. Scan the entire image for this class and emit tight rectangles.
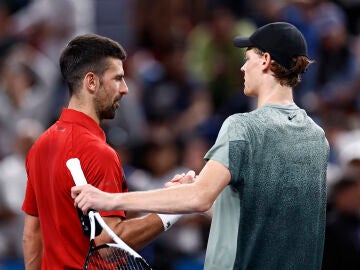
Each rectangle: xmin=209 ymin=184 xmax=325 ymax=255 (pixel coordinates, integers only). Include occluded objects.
xmin=23 ymin=35 xmax=178 ymax=270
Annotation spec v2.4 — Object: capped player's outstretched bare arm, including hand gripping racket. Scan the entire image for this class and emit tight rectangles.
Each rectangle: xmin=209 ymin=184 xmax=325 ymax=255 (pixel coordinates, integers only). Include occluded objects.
xmin=71 ymin=161 xmax=231 ymax=214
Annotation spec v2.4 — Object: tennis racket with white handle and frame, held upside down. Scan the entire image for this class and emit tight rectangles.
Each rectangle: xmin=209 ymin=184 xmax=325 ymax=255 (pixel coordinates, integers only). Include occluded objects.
xmin=66 ymin=158 xmax=151 ymax=270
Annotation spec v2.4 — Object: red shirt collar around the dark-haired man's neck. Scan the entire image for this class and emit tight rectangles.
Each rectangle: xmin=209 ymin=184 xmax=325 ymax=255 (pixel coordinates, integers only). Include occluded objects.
xmin=59 ymin=108 xmax=106 ymax=141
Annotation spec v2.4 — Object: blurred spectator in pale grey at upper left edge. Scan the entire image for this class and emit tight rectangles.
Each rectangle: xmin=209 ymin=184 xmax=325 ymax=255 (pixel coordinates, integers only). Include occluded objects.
xmin=0 ymin=43 xmax=57 ymax=155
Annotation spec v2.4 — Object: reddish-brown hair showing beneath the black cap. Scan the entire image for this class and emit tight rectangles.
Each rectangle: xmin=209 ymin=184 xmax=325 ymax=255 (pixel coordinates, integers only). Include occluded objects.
xmin=253 ymin=48 xmax=314 ymax=88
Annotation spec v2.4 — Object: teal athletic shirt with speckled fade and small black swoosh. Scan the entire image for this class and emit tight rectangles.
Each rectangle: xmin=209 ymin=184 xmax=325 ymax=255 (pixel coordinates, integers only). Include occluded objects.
xmin=204 ymin=104 xmax=329 ymax=270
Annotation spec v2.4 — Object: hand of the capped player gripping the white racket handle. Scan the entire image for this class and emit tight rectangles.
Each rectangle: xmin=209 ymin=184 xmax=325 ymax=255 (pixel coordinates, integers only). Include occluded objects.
xmin=71 ymin=184 xmax=114 ymax=215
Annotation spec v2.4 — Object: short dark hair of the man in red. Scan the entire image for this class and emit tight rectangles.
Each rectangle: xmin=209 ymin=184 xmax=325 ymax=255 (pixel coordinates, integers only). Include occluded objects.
xmin=59 ymin=34 xmax=126 ymax=96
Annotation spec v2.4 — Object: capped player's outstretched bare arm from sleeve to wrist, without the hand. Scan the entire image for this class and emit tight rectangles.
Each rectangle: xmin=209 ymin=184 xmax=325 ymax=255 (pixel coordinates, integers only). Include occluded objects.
xmin=109 ymin=161 xmax=231 ymax=213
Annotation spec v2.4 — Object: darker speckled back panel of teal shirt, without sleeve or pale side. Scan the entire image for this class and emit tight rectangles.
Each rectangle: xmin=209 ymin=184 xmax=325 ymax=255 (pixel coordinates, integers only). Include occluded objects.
xmin=236 ymin=105 xmax=329 ymax=270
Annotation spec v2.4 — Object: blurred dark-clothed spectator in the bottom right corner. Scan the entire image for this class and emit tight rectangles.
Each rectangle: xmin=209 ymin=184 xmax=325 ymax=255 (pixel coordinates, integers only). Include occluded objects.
xmin=322 ymin=174 xmax=360 ymax=270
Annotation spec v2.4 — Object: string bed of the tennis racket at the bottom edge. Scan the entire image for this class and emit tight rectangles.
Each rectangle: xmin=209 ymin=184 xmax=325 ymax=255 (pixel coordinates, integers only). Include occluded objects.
xmin=85 ymin=246 xmax=151 ymax=270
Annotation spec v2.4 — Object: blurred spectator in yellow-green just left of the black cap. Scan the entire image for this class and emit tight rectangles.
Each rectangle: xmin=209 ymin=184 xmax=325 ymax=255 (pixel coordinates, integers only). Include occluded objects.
xmin=187 ymin=5 xmax=255 ymax=117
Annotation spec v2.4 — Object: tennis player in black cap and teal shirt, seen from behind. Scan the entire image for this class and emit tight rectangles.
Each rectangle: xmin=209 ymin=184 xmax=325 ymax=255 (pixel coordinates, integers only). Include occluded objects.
xmin=72 ymin=22 xmax=329 ymax=270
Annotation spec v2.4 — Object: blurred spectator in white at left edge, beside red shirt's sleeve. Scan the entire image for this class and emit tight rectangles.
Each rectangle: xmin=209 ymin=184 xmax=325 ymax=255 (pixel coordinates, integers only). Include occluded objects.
xmin=0 ymin=119 xmax=44 ymax=259
